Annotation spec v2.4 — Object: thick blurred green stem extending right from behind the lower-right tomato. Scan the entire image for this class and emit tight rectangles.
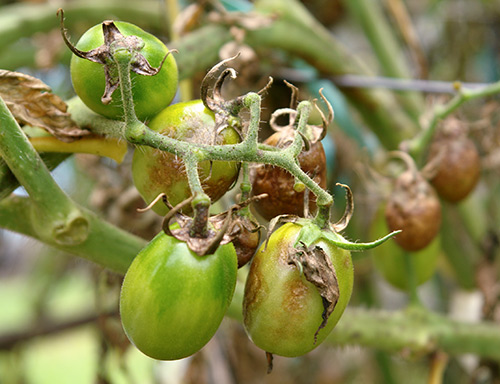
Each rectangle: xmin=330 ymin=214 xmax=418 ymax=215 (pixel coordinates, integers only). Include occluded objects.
xmin=227 ymin=282 xmax=500 ymax=361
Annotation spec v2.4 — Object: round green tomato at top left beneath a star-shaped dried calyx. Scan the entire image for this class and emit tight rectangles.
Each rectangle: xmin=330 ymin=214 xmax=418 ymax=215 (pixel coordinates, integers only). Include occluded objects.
xmin=70 ymin=21 xmax=178 ymax=120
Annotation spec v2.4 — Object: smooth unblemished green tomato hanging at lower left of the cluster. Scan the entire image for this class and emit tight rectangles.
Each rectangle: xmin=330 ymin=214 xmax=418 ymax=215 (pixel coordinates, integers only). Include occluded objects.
xmin=120 ymin=232 xmax=237 ymax=360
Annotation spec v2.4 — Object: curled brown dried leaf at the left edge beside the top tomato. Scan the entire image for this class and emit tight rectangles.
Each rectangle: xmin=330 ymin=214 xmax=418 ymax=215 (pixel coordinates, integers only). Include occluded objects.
xmin=0 ymin=70 xmax=90 ymax=142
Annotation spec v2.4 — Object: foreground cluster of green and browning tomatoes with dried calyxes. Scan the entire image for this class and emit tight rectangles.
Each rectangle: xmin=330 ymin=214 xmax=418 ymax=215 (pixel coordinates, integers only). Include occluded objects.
xmin=63 ymin=17 xmax=394 ymax=366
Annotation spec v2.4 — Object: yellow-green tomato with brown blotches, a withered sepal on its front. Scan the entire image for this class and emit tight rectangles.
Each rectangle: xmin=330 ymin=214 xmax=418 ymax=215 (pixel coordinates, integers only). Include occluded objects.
xmin=243 ymin=223 xmax=354 ymax=357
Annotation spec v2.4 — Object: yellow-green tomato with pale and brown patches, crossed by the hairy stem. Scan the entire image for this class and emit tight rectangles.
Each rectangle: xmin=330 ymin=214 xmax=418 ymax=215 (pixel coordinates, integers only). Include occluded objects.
xmin=132 ymin=100 xmax=240 ymax=216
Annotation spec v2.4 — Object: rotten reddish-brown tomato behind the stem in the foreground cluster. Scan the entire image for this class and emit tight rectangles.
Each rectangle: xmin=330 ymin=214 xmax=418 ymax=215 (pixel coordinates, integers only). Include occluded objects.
xmin=252 ymin=130 xmax=326 ymax=220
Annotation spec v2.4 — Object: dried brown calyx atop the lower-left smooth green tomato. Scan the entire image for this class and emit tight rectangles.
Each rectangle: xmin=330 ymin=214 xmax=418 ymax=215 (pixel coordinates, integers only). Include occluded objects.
xmin=159 ymin=194 xmax=265 ymax=256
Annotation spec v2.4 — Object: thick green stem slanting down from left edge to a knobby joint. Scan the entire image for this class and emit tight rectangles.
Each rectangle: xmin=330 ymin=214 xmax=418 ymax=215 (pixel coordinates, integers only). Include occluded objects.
xmin=0 ymin=98 xmax=88 ymax=244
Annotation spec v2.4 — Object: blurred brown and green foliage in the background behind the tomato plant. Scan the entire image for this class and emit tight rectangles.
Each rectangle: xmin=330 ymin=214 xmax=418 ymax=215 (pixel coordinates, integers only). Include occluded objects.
xmin=0 ymin=0 xmax=500 ymax=384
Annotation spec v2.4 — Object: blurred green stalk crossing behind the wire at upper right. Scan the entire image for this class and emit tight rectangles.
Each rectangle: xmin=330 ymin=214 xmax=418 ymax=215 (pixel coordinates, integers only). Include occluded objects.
xmin=343 ymin=0 xmax=425 ymax=122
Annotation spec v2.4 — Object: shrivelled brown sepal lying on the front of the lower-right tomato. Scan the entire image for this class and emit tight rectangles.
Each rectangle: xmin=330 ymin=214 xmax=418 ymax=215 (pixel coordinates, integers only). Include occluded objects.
xmin=288 ymin=243 xmax=340 ymax=343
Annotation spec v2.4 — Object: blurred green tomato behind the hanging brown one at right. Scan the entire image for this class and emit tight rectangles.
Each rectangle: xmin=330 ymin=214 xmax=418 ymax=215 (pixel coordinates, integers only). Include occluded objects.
xmin=371 ymin=209 xmax=441 ymax=290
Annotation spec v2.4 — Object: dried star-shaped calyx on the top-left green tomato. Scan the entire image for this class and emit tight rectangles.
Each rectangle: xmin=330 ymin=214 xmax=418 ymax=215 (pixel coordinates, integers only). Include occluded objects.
xmin=57 ymin=8 xmax=172 ymax=104
